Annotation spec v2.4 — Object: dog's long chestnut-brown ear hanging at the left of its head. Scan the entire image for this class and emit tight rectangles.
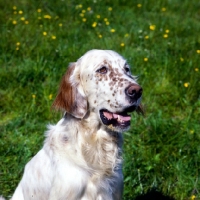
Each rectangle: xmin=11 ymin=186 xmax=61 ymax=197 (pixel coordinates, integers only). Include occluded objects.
xmin=52 ymin=63 xmax=87 ymax=119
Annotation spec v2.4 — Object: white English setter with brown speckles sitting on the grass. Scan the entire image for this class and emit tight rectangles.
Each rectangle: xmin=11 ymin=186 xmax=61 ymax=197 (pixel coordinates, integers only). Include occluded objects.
xmin=1 ymin=50 xmax=142 ymax=200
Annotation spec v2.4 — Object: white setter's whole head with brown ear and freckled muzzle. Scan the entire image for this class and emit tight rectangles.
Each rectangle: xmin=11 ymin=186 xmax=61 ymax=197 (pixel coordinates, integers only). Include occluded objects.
xmin=53 ymin=50 xmax=142 ymax=132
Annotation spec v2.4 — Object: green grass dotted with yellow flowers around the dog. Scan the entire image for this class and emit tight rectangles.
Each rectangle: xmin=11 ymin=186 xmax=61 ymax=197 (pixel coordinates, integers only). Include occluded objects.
xmin=0 ymin=0 xmax=200 ymax=200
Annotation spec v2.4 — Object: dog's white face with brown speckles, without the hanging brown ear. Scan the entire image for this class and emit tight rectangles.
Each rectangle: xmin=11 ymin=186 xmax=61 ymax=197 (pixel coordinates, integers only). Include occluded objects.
xmin=78 ymin=50 xmax=142 ymax=130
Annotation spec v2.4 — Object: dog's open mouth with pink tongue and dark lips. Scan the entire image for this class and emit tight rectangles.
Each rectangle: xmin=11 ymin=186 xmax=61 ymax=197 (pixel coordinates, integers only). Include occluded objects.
xmin=100 ymin=109 xmax=136 ymax=129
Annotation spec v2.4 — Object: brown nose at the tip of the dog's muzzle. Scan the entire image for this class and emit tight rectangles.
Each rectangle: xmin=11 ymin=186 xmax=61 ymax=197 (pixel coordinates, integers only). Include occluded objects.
xmin=125 ymin=84 xmax=142 ymax=101
